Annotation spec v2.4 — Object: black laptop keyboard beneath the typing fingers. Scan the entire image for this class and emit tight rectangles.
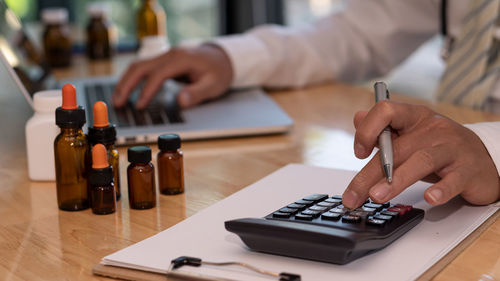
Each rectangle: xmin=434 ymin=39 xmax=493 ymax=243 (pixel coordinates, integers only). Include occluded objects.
xmin=84 ymin=83 xmax=184 ymax=127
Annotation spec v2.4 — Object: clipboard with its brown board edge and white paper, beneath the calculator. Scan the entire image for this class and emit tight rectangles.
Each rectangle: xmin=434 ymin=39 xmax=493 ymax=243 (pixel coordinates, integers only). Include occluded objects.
xmin=93 ymin=164 xmax=500 ymax=280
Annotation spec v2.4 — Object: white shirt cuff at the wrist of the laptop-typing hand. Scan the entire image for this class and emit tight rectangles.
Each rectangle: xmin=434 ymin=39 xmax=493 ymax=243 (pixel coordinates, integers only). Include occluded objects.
xmin=209 ymin=34 xmax=270 ymax=88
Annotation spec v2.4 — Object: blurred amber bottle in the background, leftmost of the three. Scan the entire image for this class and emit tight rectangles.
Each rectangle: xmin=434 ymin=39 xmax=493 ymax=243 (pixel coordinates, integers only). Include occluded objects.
xmin=42 ymin=8 xmax=72 ymax=67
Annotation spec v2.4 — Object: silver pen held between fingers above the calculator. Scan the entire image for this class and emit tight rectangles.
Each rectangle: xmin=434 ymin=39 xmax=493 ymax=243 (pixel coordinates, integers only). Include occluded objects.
xmin=373 ymin=82 xmax=394 ymax=182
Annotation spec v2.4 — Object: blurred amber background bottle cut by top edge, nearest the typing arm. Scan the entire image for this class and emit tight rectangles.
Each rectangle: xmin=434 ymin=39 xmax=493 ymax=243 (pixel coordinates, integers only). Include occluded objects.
xmin=137 ymin=0 xmax=167 ymax=41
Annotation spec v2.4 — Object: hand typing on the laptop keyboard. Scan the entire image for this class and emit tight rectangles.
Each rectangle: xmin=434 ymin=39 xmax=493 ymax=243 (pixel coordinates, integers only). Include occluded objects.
xmin=113 ymin=45 xmax=233 ymax=109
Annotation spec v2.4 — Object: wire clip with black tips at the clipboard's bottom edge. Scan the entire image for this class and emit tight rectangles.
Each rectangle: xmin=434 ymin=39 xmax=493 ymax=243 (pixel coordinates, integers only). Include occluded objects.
xmin=167 ymin=256 xmax=301 ymax=281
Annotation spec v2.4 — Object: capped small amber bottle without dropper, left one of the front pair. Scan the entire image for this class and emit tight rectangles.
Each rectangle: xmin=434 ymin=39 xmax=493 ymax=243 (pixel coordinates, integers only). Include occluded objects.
xmin=127 ymin=146 xmax=156 ymax=209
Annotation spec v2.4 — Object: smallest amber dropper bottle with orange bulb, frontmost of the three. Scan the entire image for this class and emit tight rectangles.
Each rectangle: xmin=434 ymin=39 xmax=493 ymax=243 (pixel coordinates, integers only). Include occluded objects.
xmin=89 ymin=143 xmax=116 ymax=215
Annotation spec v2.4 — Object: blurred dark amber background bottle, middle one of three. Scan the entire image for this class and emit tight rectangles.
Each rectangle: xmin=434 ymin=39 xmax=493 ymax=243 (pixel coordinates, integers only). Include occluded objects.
xmin=87 ymin=4 xmax=113 ymax=59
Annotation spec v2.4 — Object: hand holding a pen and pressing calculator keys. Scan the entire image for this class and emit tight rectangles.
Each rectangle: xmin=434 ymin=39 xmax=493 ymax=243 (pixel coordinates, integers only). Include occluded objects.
xmin=343 ymin=101 xmax=500 ymax=208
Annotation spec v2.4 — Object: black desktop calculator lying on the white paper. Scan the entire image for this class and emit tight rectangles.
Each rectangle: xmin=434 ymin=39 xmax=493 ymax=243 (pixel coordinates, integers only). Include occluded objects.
xmin=225 ymin=194 xmax=424 ymax=264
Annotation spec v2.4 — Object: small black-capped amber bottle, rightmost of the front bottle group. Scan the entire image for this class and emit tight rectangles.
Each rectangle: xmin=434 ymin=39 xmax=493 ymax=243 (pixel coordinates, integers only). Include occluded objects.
xmin=157 ymin=134 xmax=184 ymax=195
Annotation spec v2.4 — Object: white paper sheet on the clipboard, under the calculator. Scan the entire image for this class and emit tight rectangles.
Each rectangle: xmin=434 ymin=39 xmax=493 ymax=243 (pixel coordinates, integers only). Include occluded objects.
xmin=101 ymin=164 xmax=497 ymax=281
